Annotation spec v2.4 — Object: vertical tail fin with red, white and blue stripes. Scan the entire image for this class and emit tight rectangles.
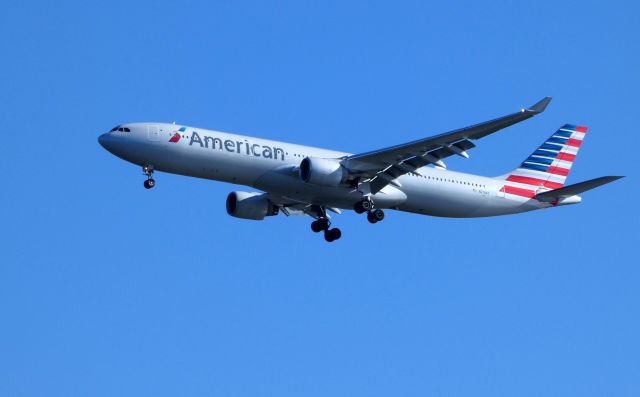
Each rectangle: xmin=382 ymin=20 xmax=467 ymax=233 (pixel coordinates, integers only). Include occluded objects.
xmin=501 ymin=124 xmax=587 ymax=198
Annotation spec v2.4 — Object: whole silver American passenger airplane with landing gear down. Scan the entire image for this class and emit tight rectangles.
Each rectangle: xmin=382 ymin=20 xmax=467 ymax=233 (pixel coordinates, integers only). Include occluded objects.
xmin=98 ymin=97 xmax=622 ymax=242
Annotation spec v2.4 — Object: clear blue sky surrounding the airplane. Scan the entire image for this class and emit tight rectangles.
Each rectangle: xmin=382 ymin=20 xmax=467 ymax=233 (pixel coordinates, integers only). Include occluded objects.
xmin=0 ymin=1 xmax=640 ymax=397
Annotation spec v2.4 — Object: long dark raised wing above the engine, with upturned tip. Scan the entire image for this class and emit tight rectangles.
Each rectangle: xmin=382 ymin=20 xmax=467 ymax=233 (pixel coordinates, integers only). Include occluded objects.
xmin=342 ymin=97 xmax=551 ymax=193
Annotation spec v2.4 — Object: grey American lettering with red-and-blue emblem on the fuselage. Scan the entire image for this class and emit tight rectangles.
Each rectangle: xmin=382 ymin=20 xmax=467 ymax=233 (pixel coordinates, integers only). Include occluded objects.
xmin=184 ymin=131 xmax=285 ymax=161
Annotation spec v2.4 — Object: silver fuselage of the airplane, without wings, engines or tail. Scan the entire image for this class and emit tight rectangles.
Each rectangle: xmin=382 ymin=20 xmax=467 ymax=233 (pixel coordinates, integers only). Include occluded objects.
xmin=99 ymin=123 xmax=551 ymax=218
